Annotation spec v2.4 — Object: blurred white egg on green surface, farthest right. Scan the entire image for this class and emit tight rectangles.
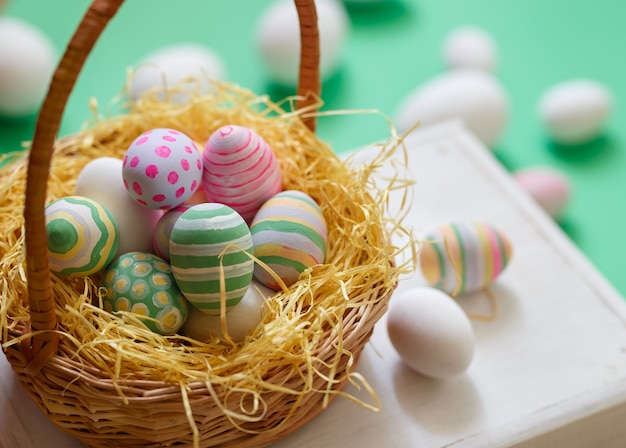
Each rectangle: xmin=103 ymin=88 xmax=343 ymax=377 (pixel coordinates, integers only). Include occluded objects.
xmin=539 ymin=79 xmax=613 ymax=145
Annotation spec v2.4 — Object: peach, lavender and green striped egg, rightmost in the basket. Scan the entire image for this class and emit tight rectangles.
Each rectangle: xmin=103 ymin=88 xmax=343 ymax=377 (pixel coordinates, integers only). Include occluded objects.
xmin=250 ymin=190 xmax=328 ymax=290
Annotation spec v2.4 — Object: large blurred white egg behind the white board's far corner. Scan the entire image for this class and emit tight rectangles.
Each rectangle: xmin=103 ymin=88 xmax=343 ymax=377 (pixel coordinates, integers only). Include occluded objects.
xmin=396 ymin=69 xmax=509 ymax=147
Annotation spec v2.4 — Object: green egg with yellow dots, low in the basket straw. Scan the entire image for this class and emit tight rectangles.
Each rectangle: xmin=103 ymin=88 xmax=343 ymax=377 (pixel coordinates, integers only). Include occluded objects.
xmin=101 ymin=252 xmax=189 ymax=335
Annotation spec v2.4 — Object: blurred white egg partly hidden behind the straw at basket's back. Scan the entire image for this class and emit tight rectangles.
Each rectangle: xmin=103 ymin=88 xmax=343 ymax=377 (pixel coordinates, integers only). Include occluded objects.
xmin=129 ymin=44 xmax=226 ymax=103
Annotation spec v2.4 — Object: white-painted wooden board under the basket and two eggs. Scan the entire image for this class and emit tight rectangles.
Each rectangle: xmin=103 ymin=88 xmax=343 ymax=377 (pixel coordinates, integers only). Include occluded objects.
xmin=0 ymin=123 xmax=626 ymax=448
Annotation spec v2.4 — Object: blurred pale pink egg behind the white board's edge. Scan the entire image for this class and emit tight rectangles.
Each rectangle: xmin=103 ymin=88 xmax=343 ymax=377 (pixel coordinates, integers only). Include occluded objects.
xmin=513 ymin=167 xmax=572 ymax=219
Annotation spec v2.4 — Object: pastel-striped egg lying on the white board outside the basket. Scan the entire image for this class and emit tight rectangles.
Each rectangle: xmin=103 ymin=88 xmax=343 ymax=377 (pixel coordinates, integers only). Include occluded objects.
xmin=420 ymin=221 xmax=512 ymax=295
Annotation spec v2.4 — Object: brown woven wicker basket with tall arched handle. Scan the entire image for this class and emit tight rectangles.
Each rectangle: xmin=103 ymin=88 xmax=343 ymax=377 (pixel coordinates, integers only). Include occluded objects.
xmin=0 ymin=0 xmax=398 ymax=447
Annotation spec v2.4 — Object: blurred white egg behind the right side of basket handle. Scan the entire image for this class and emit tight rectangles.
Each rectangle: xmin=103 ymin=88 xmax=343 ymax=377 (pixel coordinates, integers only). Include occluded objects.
xmin=256 ymin=0 xmax=350 ymax=86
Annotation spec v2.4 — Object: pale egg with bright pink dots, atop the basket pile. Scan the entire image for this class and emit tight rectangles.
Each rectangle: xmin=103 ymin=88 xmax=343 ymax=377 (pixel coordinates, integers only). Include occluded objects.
xmin=122 ymin=128 xmax=202 ymax=210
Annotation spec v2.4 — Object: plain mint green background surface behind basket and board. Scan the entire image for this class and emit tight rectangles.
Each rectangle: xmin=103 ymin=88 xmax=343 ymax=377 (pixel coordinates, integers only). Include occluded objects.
xmin=0 ymin=0 xmax=626 ymax=295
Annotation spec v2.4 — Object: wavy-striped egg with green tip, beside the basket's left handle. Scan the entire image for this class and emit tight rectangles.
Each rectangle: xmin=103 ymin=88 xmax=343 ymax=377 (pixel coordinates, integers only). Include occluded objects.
xmin=45 ymin=196 xmax=119 ymax=277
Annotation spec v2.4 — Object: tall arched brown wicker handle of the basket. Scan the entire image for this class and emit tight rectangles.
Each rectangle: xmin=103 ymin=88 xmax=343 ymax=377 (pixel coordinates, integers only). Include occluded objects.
xmin=22 ymin=0 xmax=321 ymax=374
